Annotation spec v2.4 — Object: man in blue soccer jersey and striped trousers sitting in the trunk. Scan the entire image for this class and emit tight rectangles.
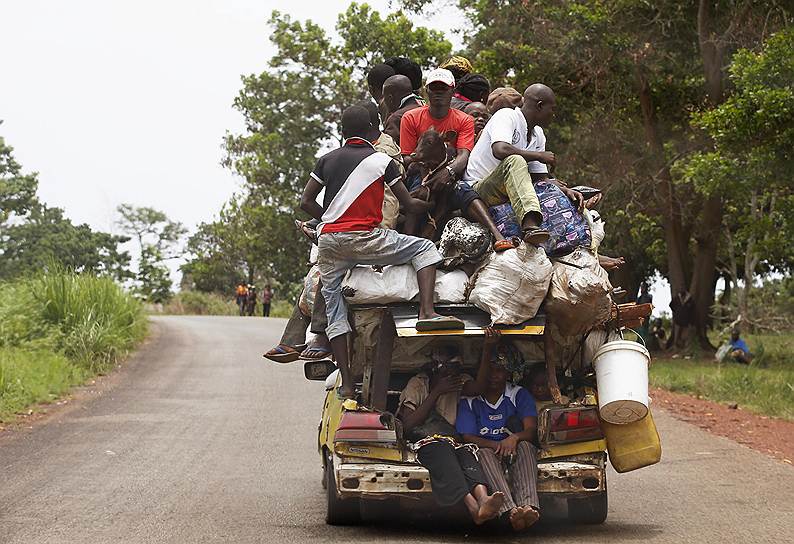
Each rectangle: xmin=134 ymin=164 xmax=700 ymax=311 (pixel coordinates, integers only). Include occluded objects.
xmin=455 ymin=342 xmax=540 ymax=531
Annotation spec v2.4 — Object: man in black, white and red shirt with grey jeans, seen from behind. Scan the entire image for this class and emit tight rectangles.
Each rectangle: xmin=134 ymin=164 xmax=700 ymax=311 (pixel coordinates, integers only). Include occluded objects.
xmin=301 ymin=106 xmax=463 ymax=398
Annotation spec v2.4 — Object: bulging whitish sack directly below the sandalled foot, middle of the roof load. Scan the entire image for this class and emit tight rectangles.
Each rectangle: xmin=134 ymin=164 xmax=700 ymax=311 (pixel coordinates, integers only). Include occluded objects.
xmin=469 ymin=243 xmax=552 ymax=325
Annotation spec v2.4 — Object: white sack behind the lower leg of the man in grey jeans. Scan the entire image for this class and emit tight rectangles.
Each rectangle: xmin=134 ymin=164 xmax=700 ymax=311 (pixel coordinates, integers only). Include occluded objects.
xmin=342 ymin=264 xmax=469 ymax=304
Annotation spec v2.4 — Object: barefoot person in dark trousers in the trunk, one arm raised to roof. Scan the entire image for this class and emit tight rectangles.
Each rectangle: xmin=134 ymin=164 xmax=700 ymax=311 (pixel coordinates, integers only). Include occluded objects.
xmin=397 ymin=329 xmax=504 ymax=525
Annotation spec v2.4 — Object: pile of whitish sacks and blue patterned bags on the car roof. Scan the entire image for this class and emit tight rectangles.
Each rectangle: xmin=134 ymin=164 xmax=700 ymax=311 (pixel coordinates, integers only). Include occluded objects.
xmin=318 ymin=182 xmax=612 ymax=336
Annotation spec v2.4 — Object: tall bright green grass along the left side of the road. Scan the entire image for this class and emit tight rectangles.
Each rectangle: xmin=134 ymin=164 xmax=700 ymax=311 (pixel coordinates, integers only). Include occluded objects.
xmin=0 ymin=270 xmax=146 ymax=421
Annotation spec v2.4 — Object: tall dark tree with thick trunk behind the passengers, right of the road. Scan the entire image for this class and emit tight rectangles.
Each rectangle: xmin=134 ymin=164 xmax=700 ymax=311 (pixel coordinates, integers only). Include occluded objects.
xmin=403 ymin=0 xmax=791 ymax=347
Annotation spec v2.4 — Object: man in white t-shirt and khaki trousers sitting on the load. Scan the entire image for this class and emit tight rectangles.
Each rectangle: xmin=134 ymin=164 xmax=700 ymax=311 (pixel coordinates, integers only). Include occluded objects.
xmin=463 ymin=83 xmax=583 ymax=245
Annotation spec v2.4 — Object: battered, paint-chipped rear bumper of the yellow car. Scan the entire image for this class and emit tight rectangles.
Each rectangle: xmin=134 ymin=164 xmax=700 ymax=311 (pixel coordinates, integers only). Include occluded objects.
xmin=334 ymin=460 xmax=606 ymax=499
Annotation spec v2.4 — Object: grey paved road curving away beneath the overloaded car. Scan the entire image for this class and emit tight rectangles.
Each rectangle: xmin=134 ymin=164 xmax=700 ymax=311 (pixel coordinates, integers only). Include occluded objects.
xmin=0 ymin=317 xmax=794 ymax=544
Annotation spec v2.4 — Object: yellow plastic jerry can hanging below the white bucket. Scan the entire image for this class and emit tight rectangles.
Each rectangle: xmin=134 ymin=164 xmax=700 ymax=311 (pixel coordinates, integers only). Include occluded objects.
xmin=601 ymin=410 xmax=662 ymax=472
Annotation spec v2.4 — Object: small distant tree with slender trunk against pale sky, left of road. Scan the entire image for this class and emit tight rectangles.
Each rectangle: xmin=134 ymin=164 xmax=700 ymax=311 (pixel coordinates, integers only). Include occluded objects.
xmin=117 ymin=204 xmax=187 ymax=303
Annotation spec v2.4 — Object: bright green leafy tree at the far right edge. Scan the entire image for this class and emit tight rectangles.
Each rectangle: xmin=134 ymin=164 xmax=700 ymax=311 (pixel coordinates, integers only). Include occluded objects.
xmin=680 ymin=28 xmax=794 ymax=328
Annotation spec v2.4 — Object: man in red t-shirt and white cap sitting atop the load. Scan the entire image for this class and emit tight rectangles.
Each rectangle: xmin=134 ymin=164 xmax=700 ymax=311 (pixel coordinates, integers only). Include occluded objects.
xmin=400 ymin=68 xmax=515 ymax=251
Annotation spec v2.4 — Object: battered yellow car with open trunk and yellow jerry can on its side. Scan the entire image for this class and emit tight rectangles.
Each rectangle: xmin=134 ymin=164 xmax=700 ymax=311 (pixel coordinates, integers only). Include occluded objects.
xmin=304 ymin=303 xmax=661 ymax=525
